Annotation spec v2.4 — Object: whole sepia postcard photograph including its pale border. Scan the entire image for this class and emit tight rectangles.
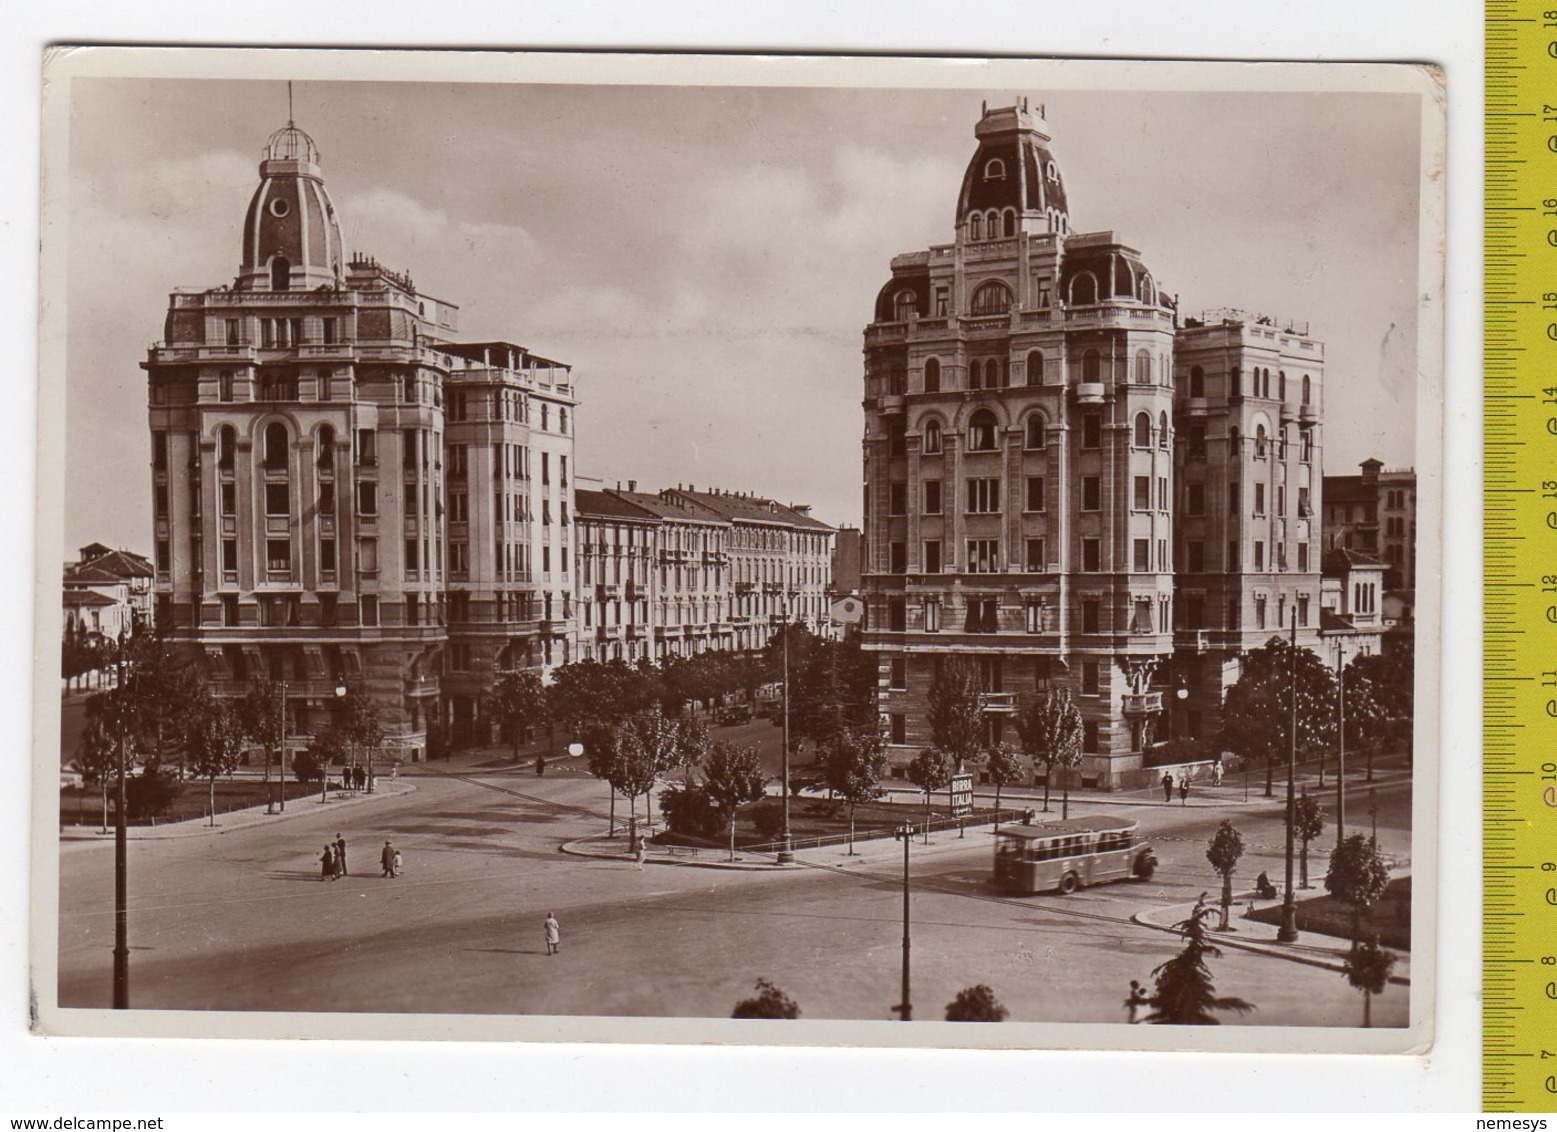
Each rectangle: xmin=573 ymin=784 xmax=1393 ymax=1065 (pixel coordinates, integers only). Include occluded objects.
xmin=33 ymin=48 xmax=1445 ymax=1053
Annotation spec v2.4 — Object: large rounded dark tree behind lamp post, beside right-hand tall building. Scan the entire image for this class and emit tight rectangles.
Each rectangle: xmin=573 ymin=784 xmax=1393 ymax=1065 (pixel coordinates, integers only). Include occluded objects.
xmin=1221 ymin=637 xmax=1336 ymax=797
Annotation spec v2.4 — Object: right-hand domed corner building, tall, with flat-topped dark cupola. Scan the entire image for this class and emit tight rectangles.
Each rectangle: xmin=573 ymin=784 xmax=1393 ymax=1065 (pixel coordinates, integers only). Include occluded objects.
xmin=864 ymin=100 xmax=1323 ymax=789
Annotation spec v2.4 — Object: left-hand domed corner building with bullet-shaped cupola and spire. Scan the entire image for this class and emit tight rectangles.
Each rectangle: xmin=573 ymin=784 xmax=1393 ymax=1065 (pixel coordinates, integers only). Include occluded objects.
xmin=143 ymin=123 xmax=578 ymax=758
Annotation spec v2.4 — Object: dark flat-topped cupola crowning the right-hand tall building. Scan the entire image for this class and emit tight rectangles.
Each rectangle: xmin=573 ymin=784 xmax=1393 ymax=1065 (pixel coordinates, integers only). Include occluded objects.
xmin=956 ymin=98 xmax=1070 ymax=240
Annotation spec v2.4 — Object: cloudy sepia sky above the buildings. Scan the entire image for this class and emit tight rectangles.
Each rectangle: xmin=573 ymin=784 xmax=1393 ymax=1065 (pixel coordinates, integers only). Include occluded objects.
xmin=57 ymin=78 xmax=1420 ymax=554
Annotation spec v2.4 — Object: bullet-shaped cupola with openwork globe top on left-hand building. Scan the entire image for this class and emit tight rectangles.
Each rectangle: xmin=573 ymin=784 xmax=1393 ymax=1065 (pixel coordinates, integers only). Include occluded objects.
xmin=235 ymin=121 xmax=346 ymax=291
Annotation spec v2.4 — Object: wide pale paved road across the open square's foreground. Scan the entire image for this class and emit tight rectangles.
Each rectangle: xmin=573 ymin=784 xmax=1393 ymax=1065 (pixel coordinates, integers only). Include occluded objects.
xmin=61 ymin=756 xmax=1408 ymax=1025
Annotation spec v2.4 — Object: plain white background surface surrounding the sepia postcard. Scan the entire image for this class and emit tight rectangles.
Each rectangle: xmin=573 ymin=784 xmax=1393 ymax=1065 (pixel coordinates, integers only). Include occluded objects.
xmin=0 ymin=0 xmax=1482 ymax=1127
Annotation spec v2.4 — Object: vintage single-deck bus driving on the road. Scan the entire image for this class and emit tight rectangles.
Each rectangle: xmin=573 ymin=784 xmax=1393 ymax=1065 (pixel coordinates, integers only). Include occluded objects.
xmin=995 ymin=816 xmax=1157 ymax=894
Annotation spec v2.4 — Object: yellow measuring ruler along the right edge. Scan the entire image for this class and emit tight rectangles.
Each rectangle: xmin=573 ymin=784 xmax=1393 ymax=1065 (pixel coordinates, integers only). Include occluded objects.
xmin=1482 ymin=0 xmax=1557 ymax=1112
